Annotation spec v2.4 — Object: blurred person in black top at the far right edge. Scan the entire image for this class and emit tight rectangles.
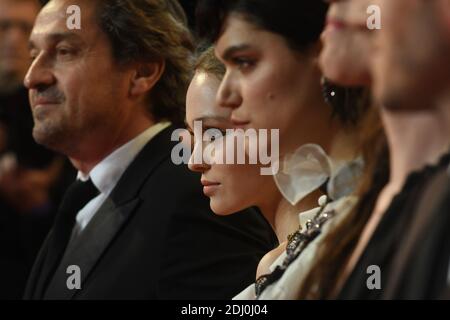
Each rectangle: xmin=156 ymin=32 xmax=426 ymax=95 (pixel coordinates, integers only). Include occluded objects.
xmin=340 ymin=0 xmax=450 ymax=299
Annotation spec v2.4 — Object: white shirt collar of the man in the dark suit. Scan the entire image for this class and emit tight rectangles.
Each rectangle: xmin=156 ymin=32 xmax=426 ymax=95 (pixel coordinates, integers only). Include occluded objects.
xmin=78 ymin=122 xmax=171 ymax=195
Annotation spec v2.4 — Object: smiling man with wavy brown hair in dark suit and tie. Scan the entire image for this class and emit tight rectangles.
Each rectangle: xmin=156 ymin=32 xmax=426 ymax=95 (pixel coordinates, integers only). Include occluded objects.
xmin=25 ymin=0 xmax=275 ymax=299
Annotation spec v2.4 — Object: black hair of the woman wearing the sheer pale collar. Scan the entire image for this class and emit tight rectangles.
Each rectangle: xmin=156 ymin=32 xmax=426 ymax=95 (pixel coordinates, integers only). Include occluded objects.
xmin=196 ymin=0 xmax=328 ymax=50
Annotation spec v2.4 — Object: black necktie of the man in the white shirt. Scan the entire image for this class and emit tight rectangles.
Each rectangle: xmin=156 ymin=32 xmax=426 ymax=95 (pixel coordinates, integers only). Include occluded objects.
xmin=44 ymin=179 xmax=99 ymax=287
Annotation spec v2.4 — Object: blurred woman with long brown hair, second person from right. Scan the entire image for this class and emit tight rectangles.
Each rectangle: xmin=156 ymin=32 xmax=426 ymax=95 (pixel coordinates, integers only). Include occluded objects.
xmin=297 ymin=0 xmax=389 ymax=299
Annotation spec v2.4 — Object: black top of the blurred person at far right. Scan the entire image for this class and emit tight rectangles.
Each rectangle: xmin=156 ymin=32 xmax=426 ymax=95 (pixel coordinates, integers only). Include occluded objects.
xmin=338 ymin=154 xmax=450 ymax=299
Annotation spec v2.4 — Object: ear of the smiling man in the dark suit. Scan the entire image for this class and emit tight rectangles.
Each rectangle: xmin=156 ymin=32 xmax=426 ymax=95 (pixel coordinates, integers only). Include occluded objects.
xmin=130 ymin=60 xmax=166 ymax=96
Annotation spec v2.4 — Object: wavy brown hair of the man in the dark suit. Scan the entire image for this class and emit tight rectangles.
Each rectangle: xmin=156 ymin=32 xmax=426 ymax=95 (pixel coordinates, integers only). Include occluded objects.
xmin=97 ymin=0 xmax=193 ymax=125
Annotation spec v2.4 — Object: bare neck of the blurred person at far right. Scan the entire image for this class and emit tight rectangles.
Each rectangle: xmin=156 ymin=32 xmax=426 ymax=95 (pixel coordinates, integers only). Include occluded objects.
xmin=381 ymin=105 xmax=450 ymax=191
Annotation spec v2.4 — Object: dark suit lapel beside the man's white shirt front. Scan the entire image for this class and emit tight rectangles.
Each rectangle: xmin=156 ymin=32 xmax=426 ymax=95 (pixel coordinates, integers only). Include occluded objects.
xmin=40 ymin=126 xmax=176 ymax=299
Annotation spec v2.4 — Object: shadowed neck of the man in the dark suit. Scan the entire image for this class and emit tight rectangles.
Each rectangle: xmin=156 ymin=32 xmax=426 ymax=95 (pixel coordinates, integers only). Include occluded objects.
xmin=69 ymin=117 xmax=155 ymax=175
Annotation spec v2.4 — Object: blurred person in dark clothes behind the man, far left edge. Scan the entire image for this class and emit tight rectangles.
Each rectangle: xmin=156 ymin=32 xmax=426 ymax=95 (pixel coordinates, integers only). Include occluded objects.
xmin=0 ymin=0 xmax=74 ymax=299
